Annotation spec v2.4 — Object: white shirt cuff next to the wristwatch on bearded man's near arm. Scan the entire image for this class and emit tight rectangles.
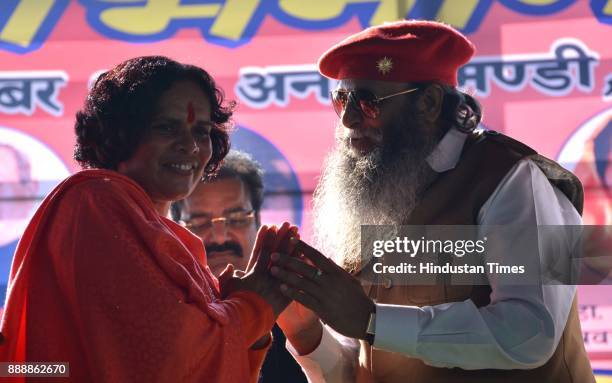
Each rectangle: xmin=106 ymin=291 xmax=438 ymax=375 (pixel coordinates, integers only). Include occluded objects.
xmin=373 ymin=304 xmax=420 ymax=356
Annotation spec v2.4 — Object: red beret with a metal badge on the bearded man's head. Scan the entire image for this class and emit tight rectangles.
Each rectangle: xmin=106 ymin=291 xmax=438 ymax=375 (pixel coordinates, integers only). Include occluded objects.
xmin=319 ymin=20 xmax=475 ymax=86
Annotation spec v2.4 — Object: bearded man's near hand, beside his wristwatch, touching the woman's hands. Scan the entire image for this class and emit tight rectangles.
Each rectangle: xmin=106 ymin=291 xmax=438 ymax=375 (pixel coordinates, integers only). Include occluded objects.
xmin=271 ymin=241 xmax=375 ymax=339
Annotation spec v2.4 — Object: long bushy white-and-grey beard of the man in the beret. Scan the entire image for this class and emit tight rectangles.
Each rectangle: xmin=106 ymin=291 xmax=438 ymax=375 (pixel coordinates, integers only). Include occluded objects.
xmin=313 ymin=126 xmax=437 ymax=272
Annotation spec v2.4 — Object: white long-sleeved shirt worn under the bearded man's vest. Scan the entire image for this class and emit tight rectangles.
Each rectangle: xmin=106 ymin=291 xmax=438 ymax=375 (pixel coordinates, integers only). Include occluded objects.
xmin=287 ymin=129 xmax=581 ymax=382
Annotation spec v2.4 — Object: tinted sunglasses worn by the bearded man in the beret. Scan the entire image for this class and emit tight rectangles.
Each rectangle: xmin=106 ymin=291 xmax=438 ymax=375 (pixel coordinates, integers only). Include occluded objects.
xmin=331 ymin=88 xmax=419 ymax=119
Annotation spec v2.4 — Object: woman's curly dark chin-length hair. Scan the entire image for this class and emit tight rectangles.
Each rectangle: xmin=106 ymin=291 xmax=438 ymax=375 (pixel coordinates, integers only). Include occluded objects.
xmin=74 ymin=56 xmax=235 ymax=176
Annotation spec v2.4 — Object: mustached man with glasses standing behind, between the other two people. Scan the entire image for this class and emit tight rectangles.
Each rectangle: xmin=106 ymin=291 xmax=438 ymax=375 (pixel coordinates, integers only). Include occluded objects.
xmin=172 ymin=150 xmax=306 ymax=383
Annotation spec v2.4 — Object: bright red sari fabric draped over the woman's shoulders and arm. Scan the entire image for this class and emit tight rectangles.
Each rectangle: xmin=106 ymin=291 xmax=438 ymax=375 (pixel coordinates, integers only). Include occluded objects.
xmin=0 ymin=170 xmax=274 ymax=382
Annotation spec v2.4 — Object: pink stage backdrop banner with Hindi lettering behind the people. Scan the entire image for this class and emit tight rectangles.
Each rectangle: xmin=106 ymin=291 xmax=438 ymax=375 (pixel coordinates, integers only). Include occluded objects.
xmin=0 ymin=0 xmax=612 ymax=381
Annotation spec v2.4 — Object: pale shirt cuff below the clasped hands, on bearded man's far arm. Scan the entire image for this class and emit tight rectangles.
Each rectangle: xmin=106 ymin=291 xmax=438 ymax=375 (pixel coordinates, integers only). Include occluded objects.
xmin=285 ymin=326 xmax=343 ymax=375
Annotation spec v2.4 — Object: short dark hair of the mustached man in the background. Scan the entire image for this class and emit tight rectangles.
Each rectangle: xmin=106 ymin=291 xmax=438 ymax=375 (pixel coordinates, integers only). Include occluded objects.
xmin=170 ymin=150 xmax=264 ymax=226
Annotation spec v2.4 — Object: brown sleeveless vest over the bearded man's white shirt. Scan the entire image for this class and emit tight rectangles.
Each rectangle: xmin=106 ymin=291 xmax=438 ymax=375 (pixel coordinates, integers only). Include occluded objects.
xmin=357 ymin=132 xmax=595 ymax=383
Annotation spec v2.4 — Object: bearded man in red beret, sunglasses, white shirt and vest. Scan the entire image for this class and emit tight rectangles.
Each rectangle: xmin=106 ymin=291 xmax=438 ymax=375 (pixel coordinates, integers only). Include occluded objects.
xmin=271 ymin=21 xmax=594 ymax=383
